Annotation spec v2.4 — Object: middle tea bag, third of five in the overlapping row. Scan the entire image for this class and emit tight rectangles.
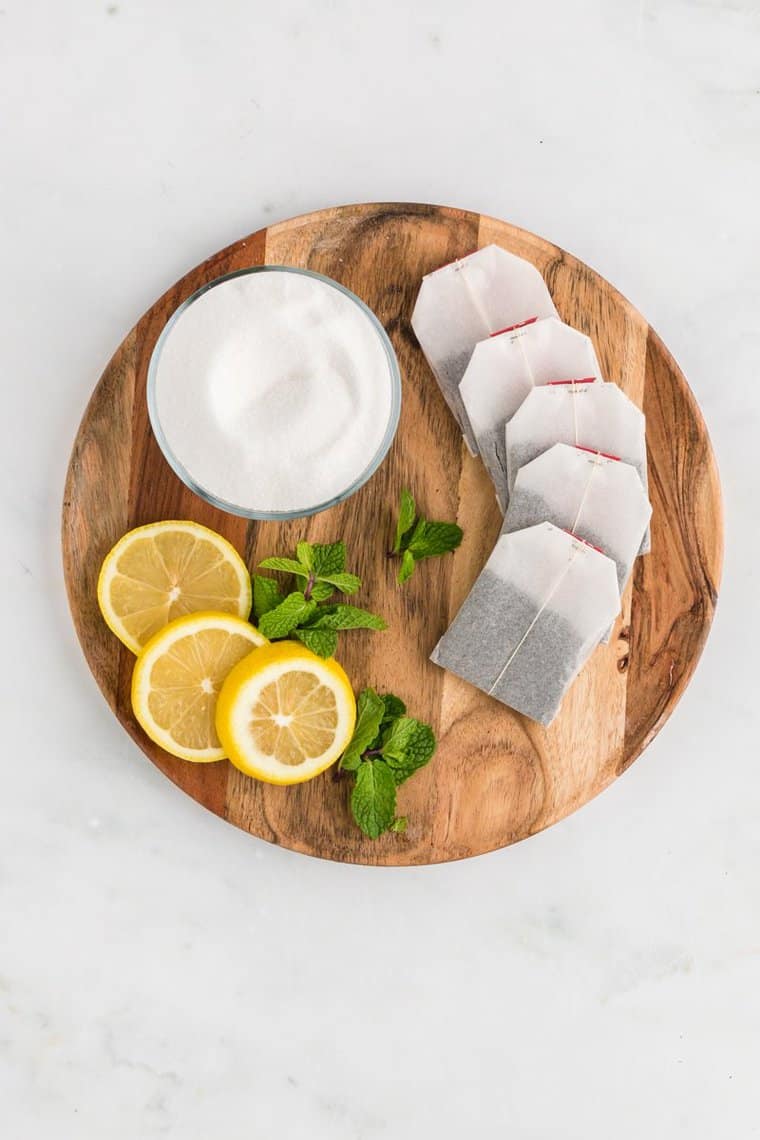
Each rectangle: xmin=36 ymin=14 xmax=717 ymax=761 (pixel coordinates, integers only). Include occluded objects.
xmin=506 ymin=382 xmax=649 ymax=554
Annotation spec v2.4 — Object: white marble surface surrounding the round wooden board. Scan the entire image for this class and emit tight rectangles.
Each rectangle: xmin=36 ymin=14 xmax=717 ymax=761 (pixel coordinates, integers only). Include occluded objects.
xmin=0 ymin=0 xmax=760 ymax=1140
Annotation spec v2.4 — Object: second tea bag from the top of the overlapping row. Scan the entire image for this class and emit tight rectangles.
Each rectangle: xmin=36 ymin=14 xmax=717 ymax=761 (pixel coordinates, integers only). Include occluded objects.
xmin=459 ymin=317 xmax=602 ymax=511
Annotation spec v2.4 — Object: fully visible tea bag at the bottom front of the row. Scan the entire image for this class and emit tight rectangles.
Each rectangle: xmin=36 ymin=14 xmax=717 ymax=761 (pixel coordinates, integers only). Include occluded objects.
xmin=431 ymin=522 xmax=620 ymax=725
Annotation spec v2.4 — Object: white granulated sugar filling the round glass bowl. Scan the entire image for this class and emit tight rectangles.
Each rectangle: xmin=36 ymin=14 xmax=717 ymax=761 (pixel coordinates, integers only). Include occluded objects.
xmin=155 ymin=272 xmax=393 ymax=512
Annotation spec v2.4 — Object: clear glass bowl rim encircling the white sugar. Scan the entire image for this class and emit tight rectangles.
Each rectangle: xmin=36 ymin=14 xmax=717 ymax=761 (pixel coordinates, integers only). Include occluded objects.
xmin=147 ymin=266 xmax=401 ymax=522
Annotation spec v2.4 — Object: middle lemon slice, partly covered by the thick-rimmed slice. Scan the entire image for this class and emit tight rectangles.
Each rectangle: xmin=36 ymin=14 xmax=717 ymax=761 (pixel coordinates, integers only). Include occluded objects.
xmin=127 ymin=613 xmax=268 ymax=763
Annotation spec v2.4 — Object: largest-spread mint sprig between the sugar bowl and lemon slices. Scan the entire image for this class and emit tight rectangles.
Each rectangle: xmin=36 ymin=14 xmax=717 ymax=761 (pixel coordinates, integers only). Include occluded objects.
xmin=253 ymin=542 xmax=385 ymax=657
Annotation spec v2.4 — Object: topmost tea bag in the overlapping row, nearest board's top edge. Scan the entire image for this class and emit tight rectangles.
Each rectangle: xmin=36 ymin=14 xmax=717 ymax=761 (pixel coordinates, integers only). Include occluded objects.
xmin=411 ymin=245 xmax=557 ymax=455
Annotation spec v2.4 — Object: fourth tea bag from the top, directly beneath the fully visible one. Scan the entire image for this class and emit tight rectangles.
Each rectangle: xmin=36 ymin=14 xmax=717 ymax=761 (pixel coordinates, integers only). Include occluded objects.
xmin=501 ymin=443 xmax=652 ymax=594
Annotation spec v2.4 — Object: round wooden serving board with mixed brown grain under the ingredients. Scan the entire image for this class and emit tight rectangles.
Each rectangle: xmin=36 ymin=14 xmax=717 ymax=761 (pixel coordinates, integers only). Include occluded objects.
xmin=63 ymin=203 xmax=722 ymax=865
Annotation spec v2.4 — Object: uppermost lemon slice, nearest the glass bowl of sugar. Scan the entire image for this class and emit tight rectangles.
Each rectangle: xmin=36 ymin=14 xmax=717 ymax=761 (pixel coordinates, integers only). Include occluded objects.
xmin=98 ymin=521 xmax=251 ymax=653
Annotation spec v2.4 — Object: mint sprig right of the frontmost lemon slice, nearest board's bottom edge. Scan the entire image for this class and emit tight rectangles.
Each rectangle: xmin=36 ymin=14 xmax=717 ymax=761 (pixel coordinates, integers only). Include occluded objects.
xmin=340 ymin=689 xmax=435 ymax=839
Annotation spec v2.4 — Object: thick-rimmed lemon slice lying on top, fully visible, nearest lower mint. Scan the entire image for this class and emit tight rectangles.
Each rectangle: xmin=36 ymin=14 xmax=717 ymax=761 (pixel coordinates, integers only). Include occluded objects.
xmin=216 ymin=641 xmax=357 ymax=784
